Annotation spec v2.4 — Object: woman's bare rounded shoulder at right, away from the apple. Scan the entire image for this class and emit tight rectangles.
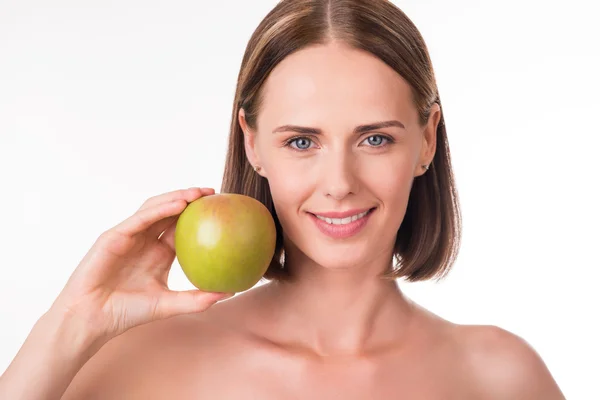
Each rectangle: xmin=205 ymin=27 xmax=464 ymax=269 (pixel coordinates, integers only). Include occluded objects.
xmin=456 ymin=325 xmax=565 ymax=400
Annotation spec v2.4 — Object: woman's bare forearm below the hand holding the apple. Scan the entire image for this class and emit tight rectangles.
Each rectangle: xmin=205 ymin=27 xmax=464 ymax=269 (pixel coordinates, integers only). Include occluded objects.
xmin=0 ymin=309 xmax=108 ymax=400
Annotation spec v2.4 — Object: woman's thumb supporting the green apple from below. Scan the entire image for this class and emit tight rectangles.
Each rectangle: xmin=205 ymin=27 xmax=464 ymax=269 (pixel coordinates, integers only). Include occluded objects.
xmin=156 ymin=289 xmax=235 ymax=318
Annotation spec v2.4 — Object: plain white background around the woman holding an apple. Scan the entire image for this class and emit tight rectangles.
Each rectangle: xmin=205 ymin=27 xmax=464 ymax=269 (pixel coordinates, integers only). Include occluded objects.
xmin=0 ymin=0 xmax=600 ymax=399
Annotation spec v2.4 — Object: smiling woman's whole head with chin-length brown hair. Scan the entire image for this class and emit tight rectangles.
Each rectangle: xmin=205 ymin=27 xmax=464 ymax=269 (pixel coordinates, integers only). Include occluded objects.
xmin=221 ymin=0 xmax=460 ymax=280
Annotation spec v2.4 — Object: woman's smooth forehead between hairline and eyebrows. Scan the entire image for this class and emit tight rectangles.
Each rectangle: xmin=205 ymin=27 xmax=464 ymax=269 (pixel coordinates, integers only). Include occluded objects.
xmin=261 ymin=45 xmax=413 ymax=126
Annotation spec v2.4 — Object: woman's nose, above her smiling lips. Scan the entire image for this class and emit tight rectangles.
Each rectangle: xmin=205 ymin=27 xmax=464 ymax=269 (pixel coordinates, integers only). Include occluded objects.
xmin=319 ymin=151 xmax=358 ymax=200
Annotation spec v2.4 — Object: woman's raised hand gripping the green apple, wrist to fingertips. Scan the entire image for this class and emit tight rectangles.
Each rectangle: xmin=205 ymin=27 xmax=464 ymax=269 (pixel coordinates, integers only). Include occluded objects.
xmin=50 ymin=188 xmax=233 ymax=338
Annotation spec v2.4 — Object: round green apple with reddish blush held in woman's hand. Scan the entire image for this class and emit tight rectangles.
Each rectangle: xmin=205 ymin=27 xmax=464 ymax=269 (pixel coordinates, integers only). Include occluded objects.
xmin=175 ymin=193 xmax=276 ymax=293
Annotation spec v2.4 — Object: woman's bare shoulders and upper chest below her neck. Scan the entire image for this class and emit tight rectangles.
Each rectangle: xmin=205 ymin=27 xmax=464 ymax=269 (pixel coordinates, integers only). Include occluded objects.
xmin=63 ymin=284 xmax=564 ymax=400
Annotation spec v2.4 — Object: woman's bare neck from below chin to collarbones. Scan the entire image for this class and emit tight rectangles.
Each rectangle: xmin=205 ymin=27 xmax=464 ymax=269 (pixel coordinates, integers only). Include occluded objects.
xmin=265 ymin=248 xmax=413 ymax=356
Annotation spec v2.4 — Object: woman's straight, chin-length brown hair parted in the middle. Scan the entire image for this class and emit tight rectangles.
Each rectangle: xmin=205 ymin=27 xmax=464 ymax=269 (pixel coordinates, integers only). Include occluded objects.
xmin=221 ymin=0 xmax=461 ymax=281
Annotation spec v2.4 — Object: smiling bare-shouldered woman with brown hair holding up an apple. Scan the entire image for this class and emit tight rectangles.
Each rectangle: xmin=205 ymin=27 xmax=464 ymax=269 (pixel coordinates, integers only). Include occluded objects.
xmin=0 ymin=0 xmax=564 ymax=400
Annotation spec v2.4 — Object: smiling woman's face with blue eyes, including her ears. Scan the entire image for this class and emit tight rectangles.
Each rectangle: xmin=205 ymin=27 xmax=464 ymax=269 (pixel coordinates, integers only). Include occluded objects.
xmin=239 ymin=44 xmax=440 ymax=276
